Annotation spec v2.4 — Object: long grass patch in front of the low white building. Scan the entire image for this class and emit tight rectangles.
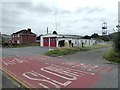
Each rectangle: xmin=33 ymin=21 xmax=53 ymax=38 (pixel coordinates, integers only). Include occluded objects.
xmin=45 ymin=47 xmax=87 ymax=56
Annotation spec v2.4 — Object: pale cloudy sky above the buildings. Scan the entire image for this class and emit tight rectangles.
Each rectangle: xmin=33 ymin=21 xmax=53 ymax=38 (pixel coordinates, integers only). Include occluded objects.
xmin=0 ymin=0 xmax=119 ymax=35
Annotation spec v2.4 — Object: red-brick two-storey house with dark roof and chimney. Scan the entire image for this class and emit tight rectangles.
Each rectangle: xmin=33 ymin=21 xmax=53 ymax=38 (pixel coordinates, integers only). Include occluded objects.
xmin=11 ymin=28 xmax=36 ymax=44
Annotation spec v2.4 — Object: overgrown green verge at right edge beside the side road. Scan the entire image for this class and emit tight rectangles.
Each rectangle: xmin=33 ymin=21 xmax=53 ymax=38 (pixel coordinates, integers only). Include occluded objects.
xmin=103 ymin=49 xmax=120 ymax=63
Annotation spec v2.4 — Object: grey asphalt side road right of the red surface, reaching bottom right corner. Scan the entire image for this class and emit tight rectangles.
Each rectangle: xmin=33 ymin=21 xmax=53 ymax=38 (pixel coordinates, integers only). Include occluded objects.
xmin=58 ymin=48 xmax=118 ymax=88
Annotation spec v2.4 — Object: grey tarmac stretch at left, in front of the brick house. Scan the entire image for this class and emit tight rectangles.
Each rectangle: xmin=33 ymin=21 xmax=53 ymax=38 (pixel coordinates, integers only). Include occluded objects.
xmin=2 ymin=46 xmax=54 ymax=57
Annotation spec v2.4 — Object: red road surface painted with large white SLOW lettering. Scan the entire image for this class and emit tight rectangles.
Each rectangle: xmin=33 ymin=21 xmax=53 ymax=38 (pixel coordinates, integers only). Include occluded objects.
xmin=1 ymin=56 xmax=99 ymax=88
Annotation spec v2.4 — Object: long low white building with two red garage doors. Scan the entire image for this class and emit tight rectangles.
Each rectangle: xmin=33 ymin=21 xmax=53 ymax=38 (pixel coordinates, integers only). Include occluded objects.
xmin=40 ymin=34 xmax=96 ymax=47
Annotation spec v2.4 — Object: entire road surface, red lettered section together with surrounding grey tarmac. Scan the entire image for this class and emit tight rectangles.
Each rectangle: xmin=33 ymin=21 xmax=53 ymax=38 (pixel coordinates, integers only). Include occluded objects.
xmin=1 ymin=47 xmax=118 ymax=88
